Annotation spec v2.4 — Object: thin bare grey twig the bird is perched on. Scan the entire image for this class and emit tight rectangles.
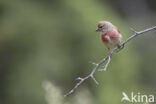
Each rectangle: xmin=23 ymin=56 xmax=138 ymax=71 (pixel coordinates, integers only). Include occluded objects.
xmin=64 ymin=26 xmax=156 ymax=98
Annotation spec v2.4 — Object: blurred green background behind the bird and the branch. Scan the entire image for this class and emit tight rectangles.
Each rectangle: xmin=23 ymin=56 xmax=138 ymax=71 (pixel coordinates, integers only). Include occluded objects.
xmin=0 ymin=0 xmax=156 ymax=104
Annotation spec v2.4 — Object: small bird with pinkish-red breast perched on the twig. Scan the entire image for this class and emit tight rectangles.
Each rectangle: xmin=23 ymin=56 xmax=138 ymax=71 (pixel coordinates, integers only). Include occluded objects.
xmin=96 ymin=21 xmax=122 ymax=50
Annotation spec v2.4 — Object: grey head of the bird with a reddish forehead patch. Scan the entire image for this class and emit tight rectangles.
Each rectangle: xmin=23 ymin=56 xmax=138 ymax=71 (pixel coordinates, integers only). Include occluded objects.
xmin=96 ymin=21 xmax=113 ymax=32
